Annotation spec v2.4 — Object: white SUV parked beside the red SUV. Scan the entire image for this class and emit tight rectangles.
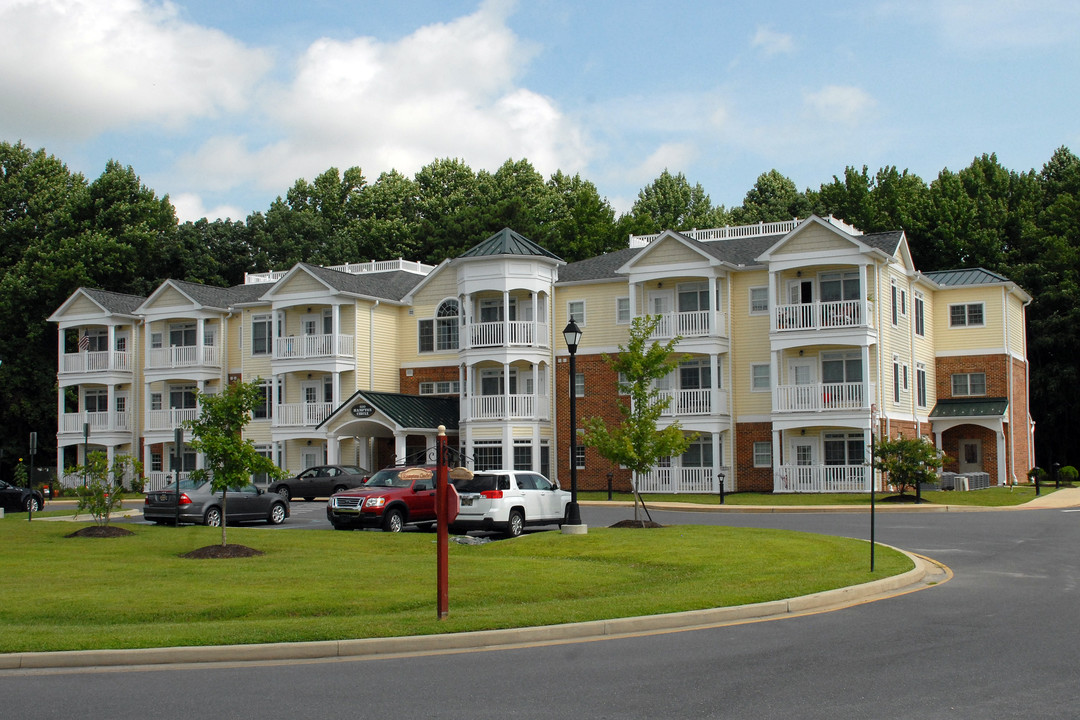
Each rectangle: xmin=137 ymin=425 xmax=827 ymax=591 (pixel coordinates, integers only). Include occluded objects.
xmin=450 ymin=470 xmax=570 ymax=538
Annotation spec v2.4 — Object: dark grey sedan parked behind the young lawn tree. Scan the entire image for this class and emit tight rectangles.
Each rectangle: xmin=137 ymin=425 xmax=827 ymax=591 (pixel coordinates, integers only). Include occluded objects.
xmin=143 ymin=479 xmax=289 ymax=527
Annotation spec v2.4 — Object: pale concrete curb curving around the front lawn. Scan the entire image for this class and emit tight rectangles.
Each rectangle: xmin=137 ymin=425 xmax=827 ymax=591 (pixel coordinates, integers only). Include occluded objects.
xmin=0 ymin=551 xmax=933 ymax=670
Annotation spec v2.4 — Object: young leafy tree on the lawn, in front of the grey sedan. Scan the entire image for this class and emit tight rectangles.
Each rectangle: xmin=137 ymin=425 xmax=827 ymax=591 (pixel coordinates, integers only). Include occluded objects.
xmin=185 ymin=379 xmax=283 ymax=547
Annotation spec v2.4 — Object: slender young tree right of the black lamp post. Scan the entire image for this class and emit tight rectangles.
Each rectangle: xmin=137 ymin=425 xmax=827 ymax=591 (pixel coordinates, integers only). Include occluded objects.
xmin=583 ymin=315 xmax=697 ymax=520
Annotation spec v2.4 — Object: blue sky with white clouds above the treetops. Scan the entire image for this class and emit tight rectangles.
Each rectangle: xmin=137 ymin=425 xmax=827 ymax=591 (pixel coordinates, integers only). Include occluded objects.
xmin=0 ymin=0 xmax=1080 ymax=221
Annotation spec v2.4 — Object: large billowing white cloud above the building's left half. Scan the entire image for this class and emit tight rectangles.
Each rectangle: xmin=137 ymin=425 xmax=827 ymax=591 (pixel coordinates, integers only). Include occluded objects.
xmin=174 ymin=2 xmax=589 ymax=197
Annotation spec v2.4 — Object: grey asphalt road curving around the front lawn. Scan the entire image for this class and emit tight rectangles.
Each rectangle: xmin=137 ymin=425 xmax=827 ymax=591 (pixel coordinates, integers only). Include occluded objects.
xmin=0 ymin=503 xmax=1080 ymax=720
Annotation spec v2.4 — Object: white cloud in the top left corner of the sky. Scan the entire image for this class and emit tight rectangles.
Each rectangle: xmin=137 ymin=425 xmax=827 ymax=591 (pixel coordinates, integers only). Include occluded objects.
xmin=0 ymin=0 xmax=270 ymax=139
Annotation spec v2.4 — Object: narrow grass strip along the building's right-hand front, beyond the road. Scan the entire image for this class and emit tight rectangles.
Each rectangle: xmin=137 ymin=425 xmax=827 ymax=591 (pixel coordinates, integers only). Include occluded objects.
xmin=578 ymin=485 xmax=1054 ymax=507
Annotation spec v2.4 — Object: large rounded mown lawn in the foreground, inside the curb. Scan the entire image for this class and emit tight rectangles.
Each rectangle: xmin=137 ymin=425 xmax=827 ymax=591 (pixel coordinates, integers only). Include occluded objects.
xmin=0 ymin=521 xmax=912 ymax=652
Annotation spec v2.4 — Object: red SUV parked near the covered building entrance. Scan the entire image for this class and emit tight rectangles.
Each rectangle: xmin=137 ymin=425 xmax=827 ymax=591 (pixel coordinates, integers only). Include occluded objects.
xmin=326 ymin=466 xmax=435 ymax=532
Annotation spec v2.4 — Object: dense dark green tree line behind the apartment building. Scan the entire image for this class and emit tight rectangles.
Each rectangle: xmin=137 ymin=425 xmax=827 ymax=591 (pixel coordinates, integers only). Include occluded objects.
xmin=0 ymin=142 xmax=1080 ymax=477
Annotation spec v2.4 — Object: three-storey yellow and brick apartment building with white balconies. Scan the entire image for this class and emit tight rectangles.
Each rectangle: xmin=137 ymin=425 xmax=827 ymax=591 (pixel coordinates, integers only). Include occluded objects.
xmin=50 ymin=217 xmax=1034 ymax=492
